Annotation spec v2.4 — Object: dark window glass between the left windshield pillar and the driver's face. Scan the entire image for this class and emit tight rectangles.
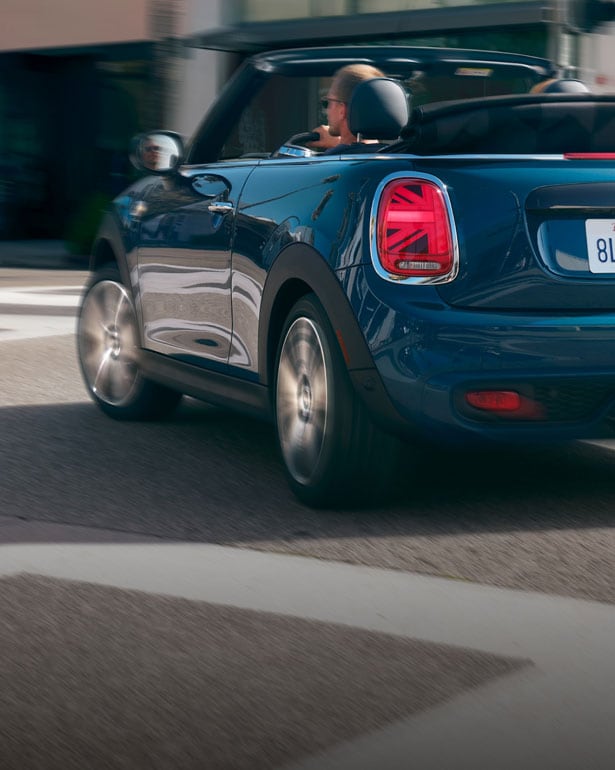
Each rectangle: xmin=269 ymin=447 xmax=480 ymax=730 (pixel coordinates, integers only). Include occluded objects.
xmin=220 ymin=75 xmax=322 ymax=160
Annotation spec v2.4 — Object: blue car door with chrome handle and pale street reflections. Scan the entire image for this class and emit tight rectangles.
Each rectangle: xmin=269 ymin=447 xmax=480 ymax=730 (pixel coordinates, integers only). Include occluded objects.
xmin=137 ymin=161 xmax=255 ymax=367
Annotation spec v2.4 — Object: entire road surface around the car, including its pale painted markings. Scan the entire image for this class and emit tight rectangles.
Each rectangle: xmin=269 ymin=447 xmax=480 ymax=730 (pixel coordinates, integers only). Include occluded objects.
xmin=0 ymin=270 xmax=615 ymax=770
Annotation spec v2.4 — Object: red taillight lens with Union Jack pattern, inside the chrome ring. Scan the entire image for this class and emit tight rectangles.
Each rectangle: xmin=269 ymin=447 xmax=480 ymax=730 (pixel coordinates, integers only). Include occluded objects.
xmin=377 ymin=179 xmax=454 ymax=277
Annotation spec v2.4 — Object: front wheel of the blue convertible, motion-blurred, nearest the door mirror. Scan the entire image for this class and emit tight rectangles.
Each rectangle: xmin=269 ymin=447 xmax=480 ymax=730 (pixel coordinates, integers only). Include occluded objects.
xmin=77 ymin=266 xmax=181 ymax=420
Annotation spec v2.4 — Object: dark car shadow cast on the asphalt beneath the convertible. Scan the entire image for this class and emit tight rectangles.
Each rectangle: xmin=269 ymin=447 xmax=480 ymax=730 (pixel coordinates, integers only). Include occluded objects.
xmin=0 ymin=392 xmax=615 ymax=541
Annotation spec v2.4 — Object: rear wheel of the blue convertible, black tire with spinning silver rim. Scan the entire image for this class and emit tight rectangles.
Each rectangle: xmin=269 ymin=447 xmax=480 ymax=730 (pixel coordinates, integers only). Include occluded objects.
xmin=274 ymin=294 xmax=400 ymax=507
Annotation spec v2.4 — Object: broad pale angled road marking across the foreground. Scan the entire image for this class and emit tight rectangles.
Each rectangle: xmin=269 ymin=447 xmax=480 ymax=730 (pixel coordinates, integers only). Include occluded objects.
xmin=0 ymin=543 xmax=615 ymax=770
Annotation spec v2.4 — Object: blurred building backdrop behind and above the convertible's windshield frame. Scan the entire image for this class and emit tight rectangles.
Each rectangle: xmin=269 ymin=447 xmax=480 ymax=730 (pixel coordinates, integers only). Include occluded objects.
xmin=0 ymin=0 xmax=602 ymax=243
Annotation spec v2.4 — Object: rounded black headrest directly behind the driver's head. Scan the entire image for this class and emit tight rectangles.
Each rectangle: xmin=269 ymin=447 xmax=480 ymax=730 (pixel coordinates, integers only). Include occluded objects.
xmin=348 ymin=78 xmax=410 ymax=139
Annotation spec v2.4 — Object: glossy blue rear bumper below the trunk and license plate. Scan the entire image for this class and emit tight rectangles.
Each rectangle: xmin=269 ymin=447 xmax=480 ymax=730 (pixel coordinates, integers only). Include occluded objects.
xmin=344 ymin=268 xmax=615 ymax=441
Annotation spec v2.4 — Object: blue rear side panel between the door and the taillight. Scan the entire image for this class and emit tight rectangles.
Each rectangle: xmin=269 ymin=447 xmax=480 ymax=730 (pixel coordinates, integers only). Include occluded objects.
xmin=230 ymin=156 xmax=409 ymax=381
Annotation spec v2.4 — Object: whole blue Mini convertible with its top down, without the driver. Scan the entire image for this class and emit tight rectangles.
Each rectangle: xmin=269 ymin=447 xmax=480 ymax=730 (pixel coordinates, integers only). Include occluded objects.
xmin=78 ymin=46 xmax=615 ymax=505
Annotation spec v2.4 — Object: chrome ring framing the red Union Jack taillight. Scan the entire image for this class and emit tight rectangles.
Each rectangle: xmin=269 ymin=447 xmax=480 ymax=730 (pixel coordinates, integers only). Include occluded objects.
xmin=369 ymin=172 xmax=459 ymax=285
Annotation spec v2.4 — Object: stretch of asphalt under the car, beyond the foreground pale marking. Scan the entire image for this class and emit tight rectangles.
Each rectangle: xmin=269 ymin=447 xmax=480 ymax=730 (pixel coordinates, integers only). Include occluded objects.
xmin=0 ymin=270 xmax=615 ymax=602
